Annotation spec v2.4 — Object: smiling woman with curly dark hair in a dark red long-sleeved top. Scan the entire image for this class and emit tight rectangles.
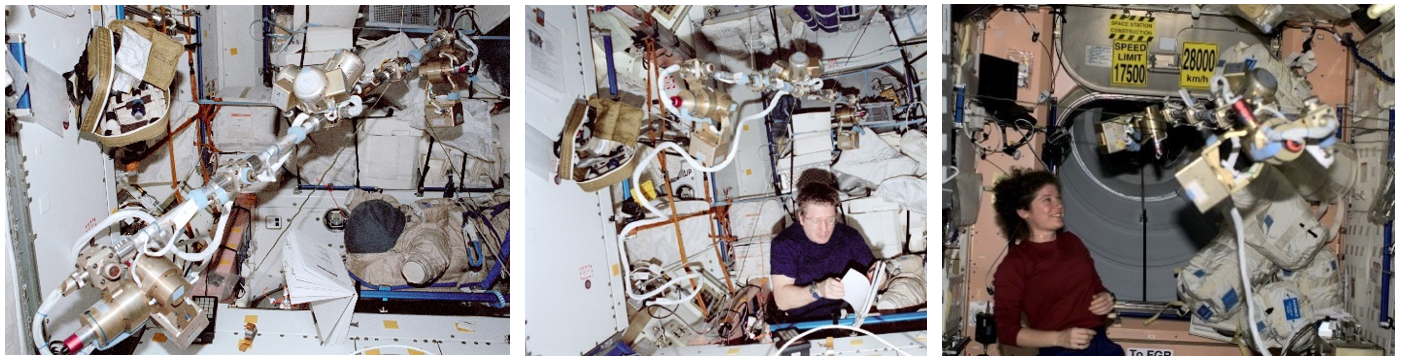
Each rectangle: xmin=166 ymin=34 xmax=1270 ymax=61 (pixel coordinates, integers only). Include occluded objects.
xmin=993 ymin=168 xmax=1124 ymax=355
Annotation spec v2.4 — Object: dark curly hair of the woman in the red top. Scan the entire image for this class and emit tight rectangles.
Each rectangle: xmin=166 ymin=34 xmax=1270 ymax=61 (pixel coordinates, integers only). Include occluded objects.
xmin=993 ymin=168 xmax=1061 ymax=243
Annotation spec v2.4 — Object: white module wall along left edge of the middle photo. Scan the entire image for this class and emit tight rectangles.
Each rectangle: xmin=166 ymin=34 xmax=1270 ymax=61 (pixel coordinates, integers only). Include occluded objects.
xmin=524 ymin=6 xmax=627 ymax=355
